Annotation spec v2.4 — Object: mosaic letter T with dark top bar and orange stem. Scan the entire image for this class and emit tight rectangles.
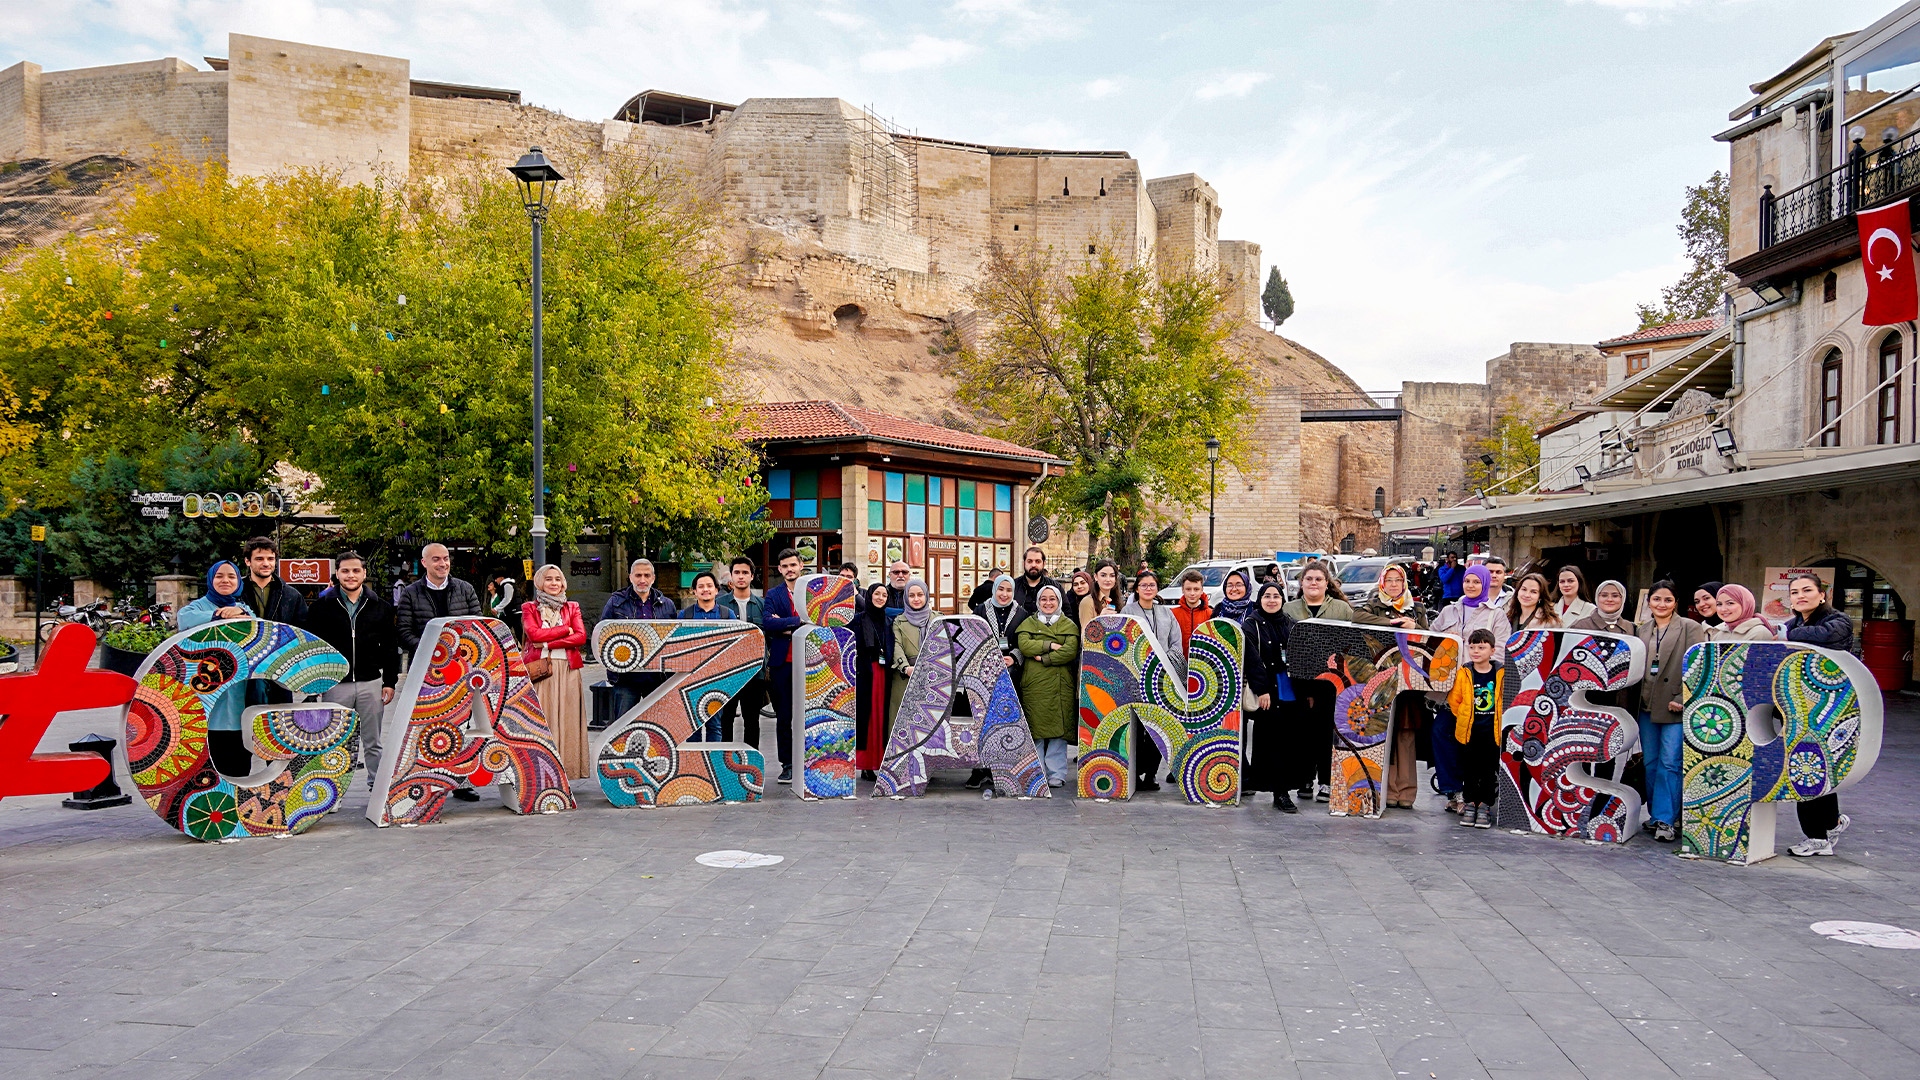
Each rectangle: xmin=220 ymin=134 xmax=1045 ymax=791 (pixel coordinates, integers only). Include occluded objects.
xmin=1286 ymin=619 xmax=1461 ymax=817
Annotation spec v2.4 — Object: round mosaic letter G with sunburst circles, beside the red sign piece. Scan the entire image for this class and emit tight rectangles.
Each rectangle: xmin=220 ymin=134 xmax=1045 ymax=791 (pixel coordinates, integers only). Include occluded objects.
xmin=127 ymin=619 xmax=357 ymax=840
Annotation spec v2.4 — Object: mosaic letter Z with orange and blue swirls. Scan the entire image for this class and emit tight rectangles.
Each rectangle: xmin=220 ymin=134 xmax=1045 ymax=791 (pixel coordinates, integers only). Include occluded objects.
xmin=593 ymin=619 xmax=766 ymax=807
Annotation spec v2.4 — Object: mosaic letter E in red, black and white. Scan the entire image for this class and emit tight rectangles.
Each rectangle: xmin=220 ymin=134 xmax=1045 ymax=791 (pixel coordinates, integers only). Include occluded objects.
xmin=1496 ymin=630 xmax=1647 ymax=844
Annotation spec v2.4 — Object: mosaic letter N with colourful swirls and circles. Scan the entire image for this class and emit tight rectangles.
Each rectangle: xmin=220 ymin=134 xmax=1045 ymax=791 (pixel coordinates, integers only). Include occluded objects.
xmin=1079 ymin=615 xmax=1244 ymax=805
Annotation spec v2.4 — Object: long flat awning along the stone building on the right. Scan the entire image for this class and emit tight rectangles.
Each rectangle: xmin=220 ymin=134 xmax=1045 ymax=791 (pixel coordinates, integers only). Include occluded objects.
xmin=1380 ymin=444 xmax=1920 ymax=534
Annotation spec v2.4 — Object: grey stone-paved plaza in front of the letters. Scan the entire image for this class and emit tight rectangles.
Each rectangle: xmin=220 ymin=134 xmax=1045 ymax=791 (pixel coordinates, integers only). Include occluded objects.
xmin=0 ymin=698 xmax=1920 ymax=1080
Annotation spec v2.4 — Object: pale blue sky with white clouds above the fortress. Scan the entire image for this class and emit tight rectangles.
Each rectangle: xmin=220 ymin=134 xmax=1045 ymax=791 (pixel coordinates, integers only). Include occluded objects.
xmin=0 ymin=0 xmax=1895 ymax=388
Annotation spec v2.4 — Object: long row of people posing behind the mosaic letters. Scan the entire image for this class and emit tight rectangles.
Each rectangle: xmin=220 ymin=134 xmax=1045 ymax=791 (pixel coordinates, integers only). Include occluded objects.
xmin=179 ymin=536 xmax=1853 ymax=855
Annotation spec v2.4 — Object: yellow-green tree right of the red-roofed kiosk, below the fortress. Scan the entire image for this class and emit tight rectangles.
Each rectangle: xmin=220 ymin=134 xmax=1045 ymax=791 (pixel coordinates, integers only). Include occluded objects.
xmin=950 ymin=244 xmax=1252 ymax=567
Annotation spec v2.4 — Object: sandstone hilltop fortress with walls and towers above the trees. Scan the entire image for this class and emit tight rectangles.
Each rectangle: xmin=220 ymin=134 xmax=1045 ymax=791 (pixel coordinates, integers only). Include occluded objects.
xmin=0 ymin=35 xmax=1599 ymax=553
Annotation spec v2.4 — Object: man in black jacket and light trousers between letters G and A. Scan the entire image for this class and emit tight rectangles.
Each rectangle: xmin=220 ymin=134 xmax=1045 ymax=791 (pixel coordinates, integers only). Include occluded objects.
xmin=307 ymin=552 xmax=399 ymax=788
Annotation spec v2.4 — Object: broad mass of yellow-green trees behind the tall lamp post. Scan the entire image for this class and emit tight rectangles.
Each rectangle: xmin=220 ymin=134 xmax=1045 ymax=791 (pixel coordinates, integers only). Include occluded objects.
xmin=0 ymin=165 xmax=764 ymax=568
